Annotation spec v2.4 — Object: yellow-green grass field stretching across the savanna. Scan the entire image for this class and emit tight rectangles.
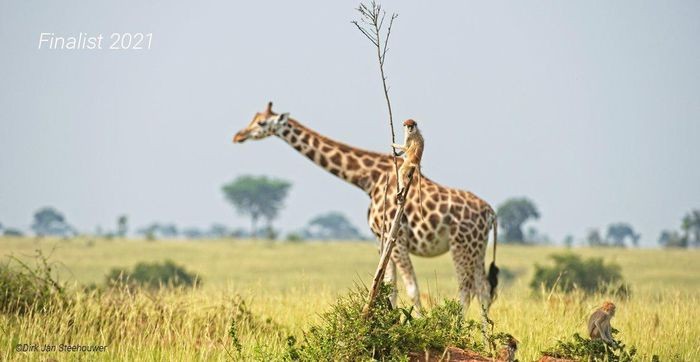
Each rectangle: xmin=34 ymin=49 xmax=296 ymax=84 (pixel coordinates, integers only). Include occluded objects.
xmin=0 ymin=238 xmax=700 ymax=361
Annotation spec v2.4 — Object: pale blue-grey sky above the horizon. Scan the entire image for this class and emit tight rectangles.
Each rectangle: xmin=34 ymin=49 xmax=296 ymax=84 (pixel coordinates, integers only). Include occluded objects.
xmin=0 ymin=1 xmax=700 ymax=244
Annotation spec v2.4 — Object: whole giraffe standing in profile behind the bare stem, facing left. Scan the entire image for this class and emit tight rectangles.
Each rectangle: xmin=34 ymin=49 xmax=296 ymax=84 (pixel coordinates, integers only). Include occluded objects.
xmin=233 ymin=102 xmax=498 ymax=311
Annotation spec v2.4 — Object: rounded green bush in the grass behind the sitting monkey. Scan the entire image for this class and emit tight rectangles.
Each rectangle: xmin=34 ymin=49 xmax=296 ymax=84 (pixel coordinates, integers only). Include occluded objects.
xmin=530 ymin=253 xmax=629 ymax=296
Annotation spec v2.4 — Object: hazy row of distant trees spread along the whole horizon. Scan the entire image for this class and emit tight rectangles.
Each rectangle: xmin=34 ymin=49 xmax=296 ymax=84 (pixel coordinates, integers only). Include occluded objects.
xmin=0 ymin=175 xmax=700 ymax=248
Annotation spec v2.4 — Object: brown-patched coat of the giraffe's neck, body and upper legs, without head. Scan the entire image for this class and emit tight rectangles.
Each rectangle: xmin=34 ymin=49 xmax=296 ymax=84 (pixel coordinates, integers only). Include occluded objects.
xmin=278 ymin=120 xmax=495 ymax=314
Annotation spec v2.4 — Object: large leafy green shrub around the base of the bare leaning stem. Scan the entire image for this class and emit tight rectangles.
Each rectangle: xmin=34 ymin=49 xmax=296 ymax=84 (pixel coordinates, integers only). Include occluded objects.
xmin=274 ymin=285 xmax=509 ymax=361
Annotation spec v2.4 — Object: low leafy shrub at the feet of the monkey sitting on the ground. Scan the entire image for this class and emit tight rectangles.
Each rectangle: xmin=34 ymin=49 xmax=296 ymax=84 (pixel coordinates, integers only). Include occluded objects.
xmin=542 ymin=328 xmax=637 ymax=362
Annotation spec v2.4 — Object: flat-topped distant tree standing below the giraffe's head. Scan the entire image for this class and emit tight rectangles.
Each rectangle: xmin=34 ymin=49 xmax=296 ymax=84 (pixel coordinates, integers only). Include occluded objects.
xmin=221 ymin=175 xmax=292 ymax=238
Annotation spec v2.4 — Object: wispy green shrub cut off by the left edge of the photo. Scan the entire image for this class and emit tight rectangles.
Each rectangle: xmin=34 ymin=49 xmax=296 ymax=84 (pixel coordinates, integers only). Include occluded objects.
xmin=0 ymin=251 xmax=68 ymax=314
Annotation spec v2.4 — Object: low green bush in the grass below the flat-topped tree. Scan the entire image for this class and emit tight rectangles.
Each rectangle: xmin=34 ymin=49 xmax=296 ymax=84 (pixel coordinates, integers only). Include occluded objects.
xmin=107 ymin=260 xmax=202 ymax=289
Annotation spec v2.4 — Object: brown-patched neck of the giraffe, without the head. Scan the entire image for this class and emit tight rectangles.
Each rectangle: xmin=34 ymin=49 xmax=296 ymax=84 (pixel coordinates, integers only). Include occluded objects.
xmin=277 ymin=119 xmax=393 ymax=193
